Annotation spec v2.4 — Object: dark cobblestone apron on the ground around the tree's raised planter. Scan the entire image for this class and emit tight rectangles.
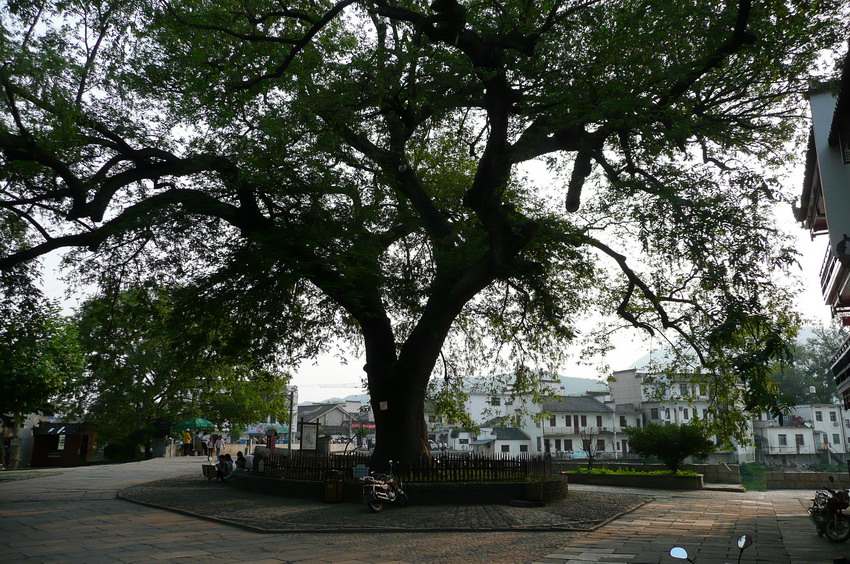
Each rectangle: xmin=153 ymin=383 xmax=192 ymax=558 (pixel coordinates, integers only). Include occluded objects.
xmin=119 ymin=476 xmax=653 ymax=533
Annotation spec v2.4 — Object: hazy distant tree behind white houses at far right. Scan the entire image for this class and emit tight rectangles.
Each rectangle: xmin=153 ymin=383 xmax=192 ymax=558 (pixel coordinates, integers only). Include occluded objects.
xmin=773 ymin=325 xmax=847 ymax=405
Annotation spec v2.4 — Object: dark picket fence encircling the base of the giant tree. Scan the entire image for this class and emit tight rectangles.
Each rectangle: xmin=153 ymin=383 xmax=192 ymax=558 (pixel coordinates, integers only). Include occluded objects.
xmin=254 ymin=451 xmax=552 ymax=483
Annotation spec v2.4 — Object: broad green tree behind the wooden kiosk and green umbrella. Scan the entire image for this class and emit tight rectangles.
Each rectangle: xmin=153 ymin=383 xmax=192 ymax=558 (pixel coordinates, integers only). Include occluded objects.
xmin=66 ymin=288 xmax=288 ymax=458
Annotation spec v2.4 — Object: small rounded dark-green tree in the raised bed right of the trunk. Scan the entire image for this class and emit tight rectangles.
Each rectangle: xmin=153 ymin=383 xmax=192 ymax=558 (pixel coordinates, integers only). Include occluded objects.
xmin=628 ymin=423 xmax=716 ymax=473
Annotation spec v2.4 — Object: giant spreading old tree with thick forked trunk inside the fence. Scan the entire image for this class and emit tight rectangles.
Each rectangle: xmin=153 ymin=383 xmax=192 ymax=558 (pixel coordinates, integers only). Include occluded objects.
xmin=0 ymin=0 xmax=846 ymax=464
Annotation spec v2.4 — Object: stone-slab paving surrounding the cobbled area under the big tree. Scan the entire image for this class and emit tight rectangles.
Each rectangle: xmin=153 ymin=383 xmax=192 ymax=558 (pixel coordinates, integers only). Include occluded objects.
xmin=0 ymin=458 xmax=850 ymax=564
